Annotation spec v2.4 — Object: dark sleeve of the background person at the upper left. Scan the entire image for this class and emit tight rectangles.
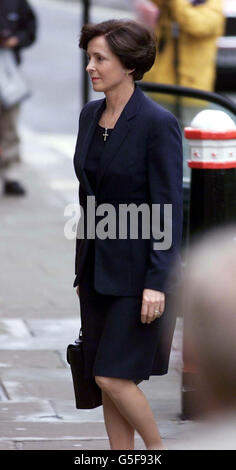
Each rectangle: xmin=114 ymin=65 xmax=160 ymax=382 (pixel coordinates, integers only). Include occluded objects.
xmin=16 ymin=0 xmax=37 ymax=49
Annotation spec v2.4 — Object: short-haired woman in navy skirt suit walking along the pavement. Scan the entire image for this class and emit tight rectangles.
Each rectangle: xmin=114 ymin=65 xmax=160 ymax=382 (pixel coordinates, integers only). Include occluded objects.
xmin=74 ymin=20 xmax=182 ymax=449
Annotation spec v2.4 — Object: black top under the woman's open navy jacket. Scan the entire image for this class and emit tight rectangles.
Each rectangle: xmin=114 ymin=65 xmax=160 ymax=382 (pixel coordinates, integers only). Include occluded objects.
xmin=84 ymin=124 xmax=113 ymax=194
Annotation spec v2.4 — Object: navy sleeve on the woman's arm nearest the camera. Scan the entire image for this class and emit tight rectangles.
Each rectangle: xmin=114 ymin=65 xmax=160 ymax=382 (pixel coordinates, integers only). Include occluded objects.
xmin=144 ymin=112 xmax=183 ymax=293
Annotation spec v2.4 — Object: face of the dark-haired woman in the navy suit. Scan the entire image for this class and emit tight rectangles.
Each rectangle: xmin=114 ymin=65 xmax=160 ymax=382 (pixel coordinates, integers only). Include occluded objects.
xmin=86 ymin=36 xmax=131 ymax=93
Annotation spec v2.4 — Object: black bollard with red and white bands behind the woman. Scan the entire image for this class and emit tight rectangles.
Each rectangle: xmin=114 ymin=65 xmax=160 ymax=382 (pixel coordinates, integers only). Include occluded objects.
xmin=182 ymin=114 xmax=236 ymax=419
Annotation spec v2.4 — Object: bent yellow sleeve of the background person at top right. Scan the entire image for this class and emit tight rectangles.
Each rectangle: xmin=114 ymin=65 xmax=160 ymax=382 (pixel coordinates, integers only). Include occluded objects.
xmin=169 ymin=0 xmax=224 ymax=37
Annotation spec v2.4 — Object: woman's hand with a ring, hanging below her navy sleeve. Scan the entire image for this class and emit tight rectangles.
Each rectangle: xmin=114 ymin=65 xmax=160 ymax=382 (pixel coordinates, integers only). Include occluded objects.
xmin=141 ymin=289 xmax=165 ymax=323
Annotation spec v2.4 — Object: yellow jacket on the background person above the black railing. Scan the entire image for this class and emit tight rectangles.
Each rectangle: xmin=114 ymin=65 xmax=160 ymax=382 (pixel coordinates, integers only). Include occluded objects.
xmin=143 ymin=0 xmax=224 ymax=91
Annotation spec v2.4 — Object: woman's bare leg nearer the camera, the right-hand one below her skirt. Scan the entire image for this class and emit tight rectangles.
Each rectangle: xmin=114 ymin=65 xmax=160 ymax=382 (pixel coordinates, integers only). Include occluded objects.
xmin=95 ymin=376 xmax=164 ymax=449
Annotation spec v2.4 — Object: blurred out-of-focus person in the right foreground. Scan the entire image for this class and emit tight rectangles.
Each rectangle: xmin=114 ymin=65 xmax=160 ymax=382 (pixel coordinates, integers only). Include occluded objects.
xmin=177 ymin=224 xmax=236 ymax=450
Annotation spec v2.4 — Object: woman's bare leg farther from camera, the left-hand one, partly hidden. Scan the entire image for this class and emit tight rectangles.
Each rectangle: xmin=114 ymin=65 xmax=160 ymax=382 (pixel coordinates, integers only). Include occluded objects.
xmin=102 ymin=391 xmax=134 ymax=450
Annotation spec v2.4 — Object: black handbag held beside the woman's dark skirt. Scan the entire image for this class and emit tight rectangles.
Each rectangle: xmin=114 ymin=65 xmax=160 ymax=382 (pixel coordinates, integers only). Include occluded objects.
xmin=67 ymin=328 xmax=102 ymax=409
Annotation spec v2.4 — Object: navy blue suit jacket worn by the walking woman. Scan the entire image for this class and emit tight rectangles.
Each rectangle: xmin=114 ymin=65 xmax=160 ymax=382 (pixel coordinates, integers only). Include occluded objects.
xmin=74 ymin=85 xmax=183 ymax=296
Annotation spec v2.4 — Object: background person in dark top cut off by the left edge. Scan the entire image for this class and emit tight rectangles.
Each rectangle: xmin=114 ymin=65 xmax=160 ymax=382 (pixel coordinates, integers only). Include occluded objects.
xmin=0 ymin=0 xmax=36 ymax=196
